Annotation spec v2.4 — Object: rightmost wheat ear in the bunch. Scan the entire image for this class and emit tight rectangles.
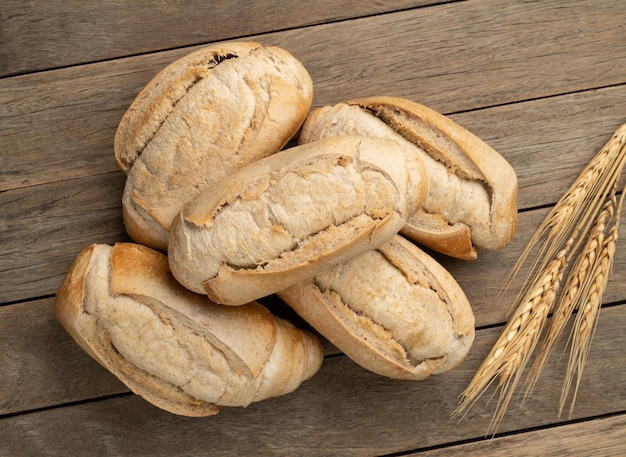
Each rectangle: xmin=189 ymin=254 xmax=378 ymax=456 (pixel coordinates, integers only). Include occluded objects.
xmin=559 ymin=186 xmax=625 ymax=418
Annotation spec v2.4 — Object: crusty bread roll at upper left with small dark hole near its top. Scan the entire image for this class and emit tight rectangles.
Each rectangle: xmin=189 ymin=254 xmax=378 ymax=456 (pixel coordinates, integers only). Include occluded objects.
xmin=114 ymin=42 xmax=313 ymax=250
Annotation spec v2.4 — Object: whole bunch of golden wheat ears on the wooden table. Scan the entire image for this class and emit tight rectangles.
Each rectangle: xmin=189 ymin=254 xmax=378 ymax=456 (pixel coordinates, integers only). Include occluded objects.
xmin=453 ymin=124 xmax=626 ymax=434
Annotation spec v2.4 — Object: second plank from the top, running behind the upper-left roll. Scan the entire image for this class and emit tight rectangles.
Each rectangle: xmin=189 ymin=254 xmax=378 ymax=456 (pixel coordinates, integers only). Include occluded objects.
xmin=0 ymin=0 xmax=626 ymax=190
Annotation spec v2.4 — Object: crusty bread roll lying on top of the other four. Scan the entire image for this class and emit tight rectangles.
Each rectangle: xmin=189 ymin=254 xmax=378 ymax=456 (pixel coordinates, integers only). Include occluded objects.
xmin=168 ymin=136 xmax=427 ymax=305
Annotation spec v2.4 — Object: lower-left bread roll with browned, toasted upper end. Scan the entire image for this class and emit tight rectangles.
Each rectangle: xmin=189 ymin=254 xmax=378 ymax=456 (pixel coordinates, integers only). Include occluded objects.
xmin=55 ymin=243 xmax=323 ymax=416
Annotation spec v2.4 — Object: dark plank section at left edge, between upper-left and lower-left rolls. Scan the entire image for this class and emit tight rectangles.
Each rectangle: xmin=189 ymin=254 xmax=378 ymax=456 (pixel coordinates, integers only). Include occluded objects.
xmin=0 ymin=171 xmax=129 ymax=303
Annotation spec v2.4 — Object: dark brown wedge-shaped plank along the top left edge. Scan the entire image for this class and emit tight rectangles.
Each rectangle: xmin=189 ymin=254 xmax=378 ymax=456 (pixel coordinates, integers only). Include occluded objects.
xmin=0 ymin=0 xmax=434 ymax=77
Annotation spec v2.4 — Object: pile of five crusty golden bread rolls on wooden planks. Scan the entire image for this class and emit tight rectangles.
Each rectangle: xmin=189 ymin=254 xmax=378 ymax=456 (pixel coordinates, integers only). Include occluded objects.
xmin=56 ymin=42 xmax=517 ymax=416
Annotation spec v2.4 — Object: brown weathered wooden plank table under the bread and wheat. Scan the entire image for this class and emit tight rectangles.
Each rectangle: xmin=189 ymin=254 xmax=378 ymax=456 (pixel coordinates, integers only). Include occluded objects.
xmin=0 ymin=0 xmax=626 ymax=456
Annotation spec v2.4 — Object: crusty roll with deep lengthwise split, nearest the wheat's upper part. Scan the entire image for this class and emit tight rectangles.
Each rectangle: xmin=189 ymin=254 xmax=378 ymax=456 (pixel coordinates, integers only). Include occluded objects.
xmin=299 ymin=97 xmax=517 ymax=260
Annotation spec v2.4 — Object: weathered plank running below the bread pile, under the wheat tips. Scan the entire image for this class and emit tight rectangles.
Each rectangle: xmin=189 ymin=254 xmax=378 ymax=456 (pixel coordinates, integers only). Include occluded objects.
xmin=0 ymin=305 xmax=626 ymax=456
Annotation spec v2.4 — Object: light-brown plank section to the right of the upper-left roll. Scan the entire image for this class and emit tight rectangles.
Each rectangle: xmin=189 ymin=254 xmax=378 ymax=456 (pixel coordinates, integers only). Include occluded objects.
xmin=276 ymin=0 xmax=626 ymax=113
